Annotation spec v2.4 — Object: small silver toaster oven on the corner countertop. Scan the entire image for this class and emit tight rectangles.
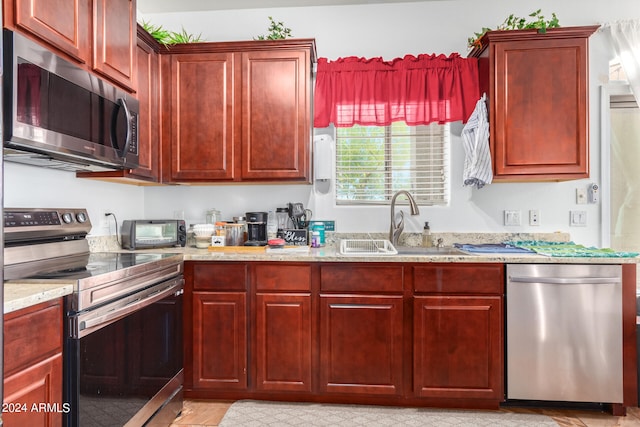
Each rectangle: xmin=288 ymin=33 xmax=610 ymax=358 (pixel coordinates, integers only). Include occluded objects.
xmin=121 ymin=219 xmax=187 ymax=249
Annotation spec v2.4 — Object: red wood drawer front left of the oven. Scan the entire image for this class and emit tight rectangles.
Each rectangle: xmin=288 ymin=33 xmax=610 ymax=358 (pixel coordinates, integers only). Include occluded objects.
xmin=4 ymin=298 xmax=62 ymax=377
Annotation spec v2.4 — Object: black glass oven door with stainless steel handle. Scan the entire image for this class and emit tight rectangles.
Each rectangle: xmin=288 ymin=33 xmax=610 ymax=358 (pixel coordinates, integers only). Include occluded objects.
xmin=64 ymin=276 xmax=184 ymax=427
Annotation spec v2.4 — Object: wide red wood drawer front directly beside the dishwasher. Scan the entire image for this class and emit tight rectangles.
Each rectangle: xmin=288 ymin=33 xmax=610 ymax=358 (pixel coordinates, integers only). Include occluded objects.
xmin=413 ymin=264 xmax=504 ymax=294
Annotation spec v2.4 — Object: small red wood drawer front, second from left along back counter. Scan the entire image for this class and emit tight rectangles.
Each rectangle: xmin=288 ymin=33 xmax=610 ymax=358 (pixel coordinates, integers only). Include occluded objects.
xmin=252 ymin=264 xmax=311 ymax=291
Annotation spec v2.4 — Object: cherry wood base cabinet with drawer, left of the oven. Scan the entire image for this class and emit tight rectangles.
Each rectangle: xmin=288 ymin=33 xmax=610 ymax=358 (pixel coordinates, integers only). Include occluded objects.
xmin=2 ymin=298 xmax=64 ymax=426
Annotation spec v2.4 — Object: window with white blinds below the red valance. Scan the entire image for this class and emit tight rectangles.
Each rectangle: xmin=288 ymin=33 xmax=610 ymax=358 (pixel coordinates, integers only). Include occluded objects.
xmin=336 ymin=122 xmax=450 ymax=205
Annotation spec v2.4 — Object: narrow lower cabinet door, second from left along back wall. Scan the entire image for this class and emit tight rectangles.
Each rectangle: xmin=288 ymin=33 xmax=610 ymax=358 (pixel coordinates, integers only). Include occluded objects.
xmin=255 ymin=293 xmax=311 ymax=391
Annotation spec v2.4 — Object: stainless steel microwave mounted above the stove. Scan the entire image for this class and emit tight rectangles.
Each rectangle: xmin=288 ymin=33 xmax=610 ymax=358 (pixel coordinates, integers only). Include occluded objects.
xmin=2 ymin=30 xmax=139 ymax=171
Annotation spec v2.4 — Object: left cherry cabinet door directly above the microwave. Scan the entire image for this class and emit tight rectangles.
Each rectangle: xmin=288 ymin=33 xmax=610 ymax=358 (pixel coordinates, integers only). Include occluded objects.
xmin=12 ymin=0 xmax=91 ymax=63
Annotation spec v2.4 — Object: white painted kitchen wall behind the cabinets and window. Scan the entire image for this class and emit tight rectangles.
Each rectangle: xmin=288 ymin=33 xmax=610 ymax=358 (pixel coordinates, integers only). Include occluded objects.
xmin=5 ymin=0 xmax=640 ymax=245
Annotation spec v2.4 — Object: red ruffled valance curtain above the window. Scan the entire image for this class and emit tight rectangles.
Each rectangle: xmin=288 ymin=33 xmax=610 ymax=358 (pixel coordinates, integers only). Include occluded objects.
xmin=314 ymin=53 xmax=480 ymax=127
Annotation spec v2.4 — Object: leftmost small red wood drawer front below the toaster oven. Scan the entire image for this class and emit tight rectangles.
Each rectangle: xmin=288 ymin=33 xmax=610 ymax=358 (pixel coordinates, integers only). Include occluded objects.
xmin=193 ymin=263 xmax=247 ymax=291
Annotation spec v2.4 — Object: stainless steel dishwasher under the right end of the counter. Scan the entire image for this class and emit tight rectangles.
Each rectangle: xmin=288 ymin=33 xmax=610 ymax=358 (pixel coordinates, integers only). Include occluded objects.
xmin=506 ymin=264 xmax=623 ymax=403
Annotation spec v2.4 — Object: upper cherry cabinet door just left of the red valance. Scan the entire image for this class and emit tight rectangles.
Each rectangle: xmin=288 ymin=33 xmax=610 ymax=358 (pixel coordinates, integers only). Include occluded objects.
xmin=240 ymin=50 xmax=311 ymax=181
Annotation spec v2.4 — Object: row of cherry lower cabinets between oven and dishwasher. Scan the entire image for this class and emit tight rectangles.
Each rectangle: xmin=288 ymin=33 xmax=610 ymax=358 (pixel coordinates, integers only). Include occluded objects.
xmin=185 ymin=261 xmax=504 ymax=408
